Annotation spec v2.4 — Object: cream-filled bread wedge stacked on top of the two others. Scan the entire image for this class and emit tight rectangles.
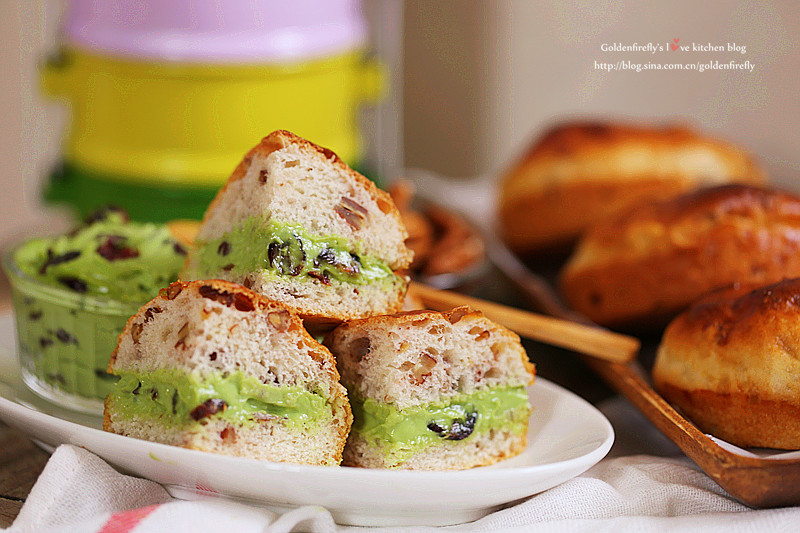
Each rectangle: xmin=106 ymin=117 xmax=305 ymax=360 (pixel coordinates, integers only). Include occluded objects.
xmin=183 ymin=131 xmax=412 ymax=324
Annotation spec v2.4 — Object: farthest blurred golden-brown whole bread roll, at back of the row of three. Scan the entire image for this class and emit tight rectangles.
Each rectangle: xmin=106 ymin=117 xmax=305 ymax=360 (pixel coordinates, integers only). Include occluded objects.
xmin=498 ymin=122 xmax=765 ymax=253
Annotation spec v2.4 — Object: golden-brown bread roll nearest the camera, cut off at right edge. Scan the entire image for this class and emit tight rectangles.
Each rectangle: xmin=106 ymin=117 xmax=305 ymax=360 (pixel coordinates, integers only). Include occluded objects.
xmin=653 ymin=278 xmax=800 ymax=449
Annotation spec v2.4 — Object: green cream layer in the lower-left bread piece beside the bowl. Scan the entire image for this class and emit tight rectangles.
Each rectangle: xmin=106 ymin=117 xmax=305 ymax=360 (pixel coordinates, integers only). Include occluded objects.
xmin=111 ymin=369 xmax=333 ymax=428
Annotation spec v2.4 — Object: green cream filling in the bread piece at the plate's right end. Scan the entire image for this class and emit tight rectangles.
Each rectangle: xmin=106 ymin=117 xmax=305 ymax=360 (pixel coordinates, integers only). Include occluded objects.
xmin=350 ymin=387 xmax=531 ymax=464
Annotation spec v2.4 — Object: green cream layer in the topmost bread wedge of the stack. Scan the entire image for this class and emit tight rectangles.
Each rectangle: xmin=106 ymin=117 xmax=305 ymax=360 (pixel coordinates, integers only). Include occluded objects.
xmin=195 ymin=217 xmax=396 ymax=285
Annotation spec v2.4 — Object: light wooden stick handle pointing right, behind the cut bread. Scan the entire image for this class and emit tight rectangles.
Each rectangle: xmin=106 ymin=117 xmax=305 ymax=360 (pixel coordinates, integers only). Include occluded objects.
xmin=409 ymin=282 xmax=640 ymax=363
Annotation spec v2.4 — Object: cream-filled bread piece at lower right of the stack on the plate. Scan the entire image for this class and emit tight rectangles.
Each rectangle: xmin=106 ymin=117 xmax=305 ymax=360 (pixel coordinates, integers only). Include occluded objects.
xmin=326 ymin=307 xmax=534 ymax=470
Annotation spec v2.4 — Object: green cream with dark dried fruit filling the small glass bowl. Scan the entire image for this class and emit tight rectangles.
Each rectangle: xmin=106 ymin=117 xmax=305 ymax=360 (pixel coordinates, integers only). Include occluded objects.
xmin=7 ymin=209 xmax=186 ymax=402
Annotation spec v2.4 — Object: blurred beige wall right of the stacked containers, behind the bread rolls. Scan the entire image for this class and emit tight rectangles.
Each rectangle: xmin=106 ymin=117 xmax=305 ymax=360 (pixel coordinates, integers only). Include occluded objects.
xmin=404 ymin=0 xmax=800 ymax=182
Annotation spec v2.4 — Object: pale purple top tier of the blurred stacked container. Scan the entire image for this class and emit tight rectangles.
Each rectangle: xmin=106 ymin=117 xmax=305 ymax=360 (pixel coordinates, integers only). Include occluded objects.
xmin=64 ymin=0 xmax=366 ymax=63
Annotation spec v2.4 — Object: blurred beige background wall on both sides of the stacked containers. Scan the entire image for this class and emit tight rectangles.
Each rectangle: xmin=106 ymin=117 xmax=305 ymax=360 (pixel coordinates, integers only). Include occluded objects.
xmin=0 ymin=0 xmax=800 ymax=240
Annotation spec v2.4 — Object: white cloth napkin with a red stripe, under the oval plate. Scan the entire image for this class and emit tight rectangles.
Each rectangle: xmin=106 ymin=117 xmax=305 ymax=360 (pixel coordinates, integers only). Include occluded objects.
xmin=6 ymin=445 xmax=800 ymax=533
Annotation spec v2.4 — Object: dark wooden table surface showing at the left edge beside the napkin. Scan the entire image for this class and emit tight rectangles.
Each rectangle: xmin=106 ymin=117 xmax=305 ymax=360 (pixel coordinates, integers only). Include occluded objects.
xmin=0 ymin=274 xmax=50 ymax=528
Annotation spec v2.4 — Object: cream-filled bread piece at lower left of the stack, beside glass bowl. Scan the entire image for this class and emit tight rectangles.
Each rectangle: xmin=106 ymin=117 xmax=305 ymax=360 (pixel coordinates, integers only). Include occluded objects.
xmin=103 ymin=280 xmax=352 ymax=465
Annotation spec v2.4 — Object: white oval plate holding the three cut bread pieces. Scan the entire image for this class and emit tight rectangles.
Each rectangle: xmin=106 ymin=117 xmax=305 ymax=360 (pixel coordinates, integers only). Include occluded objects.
xmin=0 ymin=316 xmax=614 ymax=526
